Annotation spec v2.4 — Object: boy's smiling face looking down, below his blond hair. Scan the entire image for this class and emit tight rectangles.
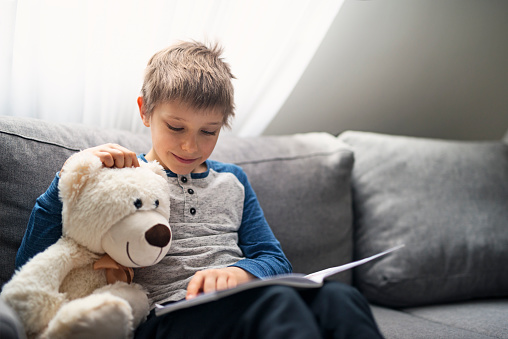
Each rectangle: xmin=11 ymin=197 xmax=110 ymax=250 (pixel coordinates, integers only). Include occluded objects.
xmin=138 ymin=99 xmax=223 ymax=174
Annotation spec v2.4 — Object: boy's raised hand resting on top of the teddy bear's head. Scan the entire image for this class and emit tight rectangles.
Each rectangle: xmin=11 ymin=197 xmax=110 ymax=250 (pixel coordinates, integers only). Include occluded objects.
xmin=62 ymin=144 xmax=139 ymax=168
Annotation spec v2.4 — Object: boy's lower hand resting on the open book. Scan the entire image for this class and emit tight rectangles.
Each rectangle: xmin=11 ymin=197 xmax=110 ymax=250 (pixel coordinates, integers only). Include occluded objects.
xmin=185 ymin=267 xmax=255 ymax=299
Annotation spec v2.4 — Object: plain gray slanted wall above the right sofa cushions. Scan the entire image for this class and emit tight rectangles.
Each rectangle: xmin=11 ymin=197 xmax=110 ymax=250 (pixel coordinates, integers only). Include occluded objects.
xmin=264 ymin=0 xmax=508 ymax=140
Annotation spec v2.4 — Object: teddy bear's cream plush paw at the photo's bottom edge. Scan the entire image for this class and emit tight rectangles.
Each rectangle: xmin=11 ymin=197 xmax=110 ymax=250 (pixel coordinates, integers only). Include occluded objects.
xmin=42 ymin=294 xmax=134 ymax=339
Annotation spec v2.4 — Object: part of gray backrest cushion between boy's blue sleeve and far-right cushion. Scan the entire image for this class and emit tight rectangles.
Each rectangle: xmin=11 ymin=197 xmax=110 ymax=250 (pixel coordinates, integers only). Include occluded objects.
xmin=211 ymin=133 xmax=354 ymax=283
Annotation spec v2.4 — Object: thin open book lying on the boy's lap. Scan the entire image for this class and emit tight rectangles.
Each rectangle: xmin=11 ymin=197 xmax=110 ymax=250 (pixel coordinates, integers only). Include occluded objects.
xmin=155 ymin=245 xmax=404 ymax=316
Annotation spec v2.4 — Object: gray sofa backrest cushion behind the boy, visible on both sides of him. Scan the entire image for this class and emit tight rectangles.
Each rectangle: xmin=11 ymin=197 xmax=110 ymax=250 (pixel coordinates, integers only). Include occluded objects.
xmin=0 ymin=117 xmax=353 ymax=286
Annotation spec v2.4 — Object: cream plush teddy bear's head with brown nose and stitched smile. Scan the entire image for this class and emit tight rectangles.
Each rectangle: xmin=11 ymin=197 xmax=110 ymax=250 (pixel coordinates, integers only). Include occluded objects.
xmin=58 ymin=152 xmax=171 ymax=267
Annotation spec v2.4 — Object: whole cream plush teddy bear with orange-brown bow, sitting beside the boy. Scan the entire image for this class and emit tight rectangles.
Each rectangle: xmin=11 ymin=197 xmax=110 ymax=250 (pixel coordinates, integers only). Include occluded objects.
xmin=0 ymin=152 xmax=172 ymax=338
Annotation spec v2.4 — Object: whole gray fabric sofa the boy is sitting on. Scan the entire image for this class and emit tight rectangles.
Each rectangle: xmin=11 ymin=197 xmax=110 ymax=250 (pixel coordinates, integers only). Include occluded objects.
xmin=0 ymin=117 xmax=508 ymax=339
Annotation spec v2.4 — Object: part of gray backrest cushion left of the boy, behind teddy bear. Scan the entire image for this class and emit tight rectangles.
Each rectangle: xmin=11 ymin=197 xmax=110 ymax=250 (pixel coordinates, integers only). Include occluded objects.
xmin=0 ymin=117 xmax=151 ymax=286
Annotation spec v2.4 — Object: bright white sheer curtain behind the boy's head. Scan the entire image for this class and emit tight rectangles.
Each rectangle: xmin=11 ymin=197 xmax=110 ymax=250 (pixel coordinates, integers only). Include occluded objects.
xmin=0 ymin=0 xmax=344 ymax=136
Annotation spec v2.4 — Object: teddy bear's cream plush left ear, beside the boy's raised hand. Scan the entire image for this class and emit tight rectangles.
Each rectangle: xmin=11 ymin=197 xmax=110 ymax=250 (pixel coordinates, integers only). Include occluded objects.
xmin=58 ymin=152 xmax=102 ymax=202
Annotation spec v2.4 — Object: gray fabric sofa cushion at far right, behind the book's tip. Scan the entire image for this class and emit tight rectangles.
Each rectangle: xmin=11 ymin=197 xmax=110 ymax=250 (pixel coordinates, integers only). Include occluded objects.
xmin=340 ymin=132 xmax=508 ymax=306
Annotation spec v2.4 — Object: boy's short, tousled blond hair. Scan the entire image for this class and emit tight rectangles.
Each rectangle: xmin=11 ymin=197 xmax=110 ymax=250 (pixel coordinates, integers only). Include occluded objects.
xmin=141 ymin=41 xmax=235 ymax=127
